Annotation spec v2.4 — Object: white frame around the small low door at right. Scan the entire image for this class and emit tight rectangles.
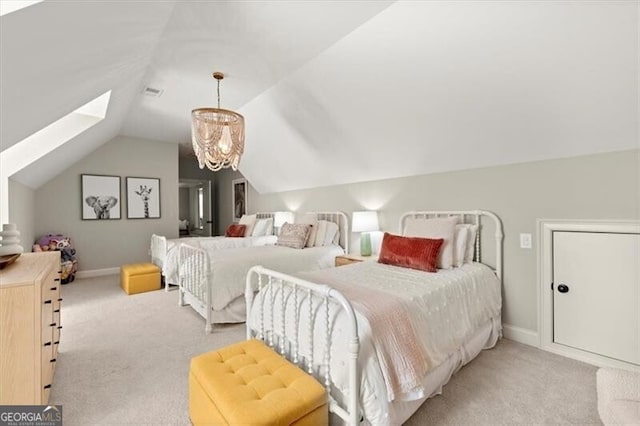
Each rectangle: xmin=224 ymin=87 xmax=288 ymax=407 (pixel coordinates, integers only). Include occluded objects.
xmin=537 ymin=219 xmax=640 ymax=371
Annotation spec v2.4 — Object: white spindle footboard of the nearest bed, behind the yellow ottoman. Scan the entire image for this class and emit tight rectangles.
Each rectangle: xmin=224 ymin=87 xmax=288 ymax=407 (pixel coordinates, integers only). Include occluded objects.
xmin=245 ymin=266 xmax=360 ymax=426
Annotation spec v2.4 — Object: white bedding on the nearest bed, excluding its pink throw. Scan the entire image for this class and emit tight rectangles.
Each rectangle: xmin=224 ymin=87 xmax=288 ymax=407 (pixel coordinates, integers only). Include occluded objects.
xmin=250 ymin=262 xmax=501 ymax=425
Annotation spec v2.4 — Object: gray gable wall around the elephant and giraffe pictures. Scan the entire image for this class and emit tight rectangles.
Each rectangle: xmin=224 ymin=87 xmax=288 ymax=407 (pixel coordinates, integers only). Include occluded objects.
xmin=36 ymin=136 xmax=178 ymax=271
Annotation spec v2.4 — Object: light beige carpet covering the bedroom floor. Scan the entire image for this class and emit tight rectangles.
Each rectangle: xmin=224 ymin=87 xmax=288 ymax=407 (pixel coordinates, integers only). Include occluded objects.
xmin=50 ymin=276 xmax=601 ymax=426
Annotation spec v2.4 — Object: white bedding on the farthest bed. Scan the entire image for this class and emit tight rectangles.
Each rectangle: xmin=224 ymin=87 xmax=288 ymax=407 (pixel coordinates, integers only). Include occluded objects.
xmin=162 ymin=235 xmax=278 ymax=284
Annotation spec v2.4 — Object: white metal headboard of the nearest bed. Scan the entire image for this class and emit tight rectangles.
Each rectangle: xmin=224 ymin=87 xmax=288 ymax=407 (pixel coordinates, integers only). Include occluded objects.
xmin=399 ymin=210 xmax=504 ymax=282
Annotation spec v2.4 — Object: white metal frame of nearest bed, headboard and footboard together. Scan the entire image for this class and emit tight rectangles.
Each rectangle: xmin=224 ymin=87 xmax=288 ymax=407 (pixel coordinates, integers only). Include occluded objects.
xmin=245 ymin=210 xmax=503 ymax=426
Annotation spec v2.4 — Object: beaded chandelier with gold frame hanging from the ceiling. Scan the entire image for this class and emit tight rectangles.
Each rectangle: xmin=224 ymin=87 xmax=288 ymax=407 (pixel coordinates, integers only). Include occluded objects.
xmin=191 ymin=72 xmax=244 ymax=172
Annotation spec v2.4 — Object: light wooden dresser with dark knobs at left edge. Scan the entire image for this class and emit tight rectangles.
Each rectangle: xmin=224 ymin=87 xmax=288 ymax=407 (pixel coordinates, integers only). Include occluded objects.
xmin=0 ymin=251 xmax=62 ymax=405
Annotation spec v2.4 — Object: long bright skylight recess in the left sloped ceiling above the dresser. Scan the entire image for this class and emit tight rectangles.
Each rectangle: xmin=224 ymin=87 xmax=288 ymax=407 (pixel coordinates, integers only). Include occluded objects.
xmin=0 ymin=90 xmax=111 ymax=223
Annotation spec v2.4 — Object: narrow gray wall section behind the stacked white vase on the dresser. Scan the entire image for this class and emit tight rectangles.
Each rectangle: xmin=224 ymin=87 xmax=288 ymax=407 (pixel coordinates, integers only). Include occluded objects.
xmin=9 ymin=179 xmax=36 ymax=252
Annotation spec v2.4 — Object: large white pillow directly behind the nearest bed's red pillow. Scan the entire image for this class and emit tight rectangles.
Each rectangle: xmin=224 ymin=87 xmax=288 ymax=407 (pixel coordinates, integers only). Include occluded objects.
xmin=402 ymin=216 xmax=460 ymax=269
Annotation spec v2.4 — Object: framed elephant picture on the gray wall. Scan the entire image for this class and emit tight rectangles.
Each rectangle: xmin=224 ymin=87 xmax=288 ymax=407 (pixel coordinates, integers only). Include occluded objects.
xmin=80 ymin=174 xmax=121 ymax=220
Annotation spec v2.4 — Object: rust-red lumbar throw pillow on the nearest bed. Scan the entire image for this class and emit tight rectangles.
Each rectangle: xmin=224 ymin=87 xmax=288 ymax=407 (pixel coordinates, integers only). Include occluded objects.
xmin=378 ymin=232 xmax=444 ymax=272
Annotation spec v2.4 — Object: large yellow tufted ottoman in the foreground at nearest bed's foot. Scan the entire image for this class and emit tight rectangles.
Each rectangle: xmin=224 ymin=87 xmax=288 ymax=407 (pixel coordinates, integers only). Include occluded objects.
xmin=189 ymin=339 xmax=329 ymax=426
